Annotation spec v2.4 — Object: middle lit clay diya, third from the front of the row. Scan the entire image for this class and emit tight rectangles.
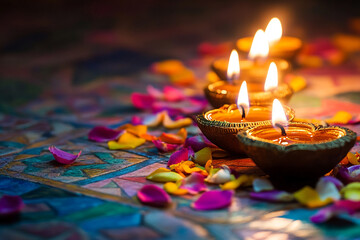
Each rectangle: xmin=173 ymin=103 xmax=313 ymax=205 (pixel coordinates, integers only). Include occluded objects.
xmin=204 ymin=54 xmax=293 ymax=108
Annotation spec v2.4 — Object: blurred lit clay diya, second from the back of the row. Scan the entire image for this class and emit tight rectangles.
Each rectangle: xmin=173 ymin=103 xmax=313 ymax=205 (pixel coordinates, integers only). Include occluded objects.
xmin=211 ymin=30 xmax=291 ymax=83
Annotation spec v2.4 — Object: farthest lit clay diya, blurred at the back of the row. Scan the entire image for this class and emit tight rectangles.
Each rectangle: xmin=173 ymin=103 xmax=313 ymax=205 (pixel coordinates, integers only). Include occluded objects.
xmin=236 ymin=18 xmax=303 ymax=60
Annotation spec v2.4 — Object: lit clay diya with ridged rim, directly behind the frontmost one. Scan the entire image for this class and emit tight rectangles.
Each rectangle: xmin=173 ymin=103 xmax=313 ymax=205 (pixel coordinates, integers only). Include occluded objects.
xmin=196 ymin=81 xmax=295 ymax=155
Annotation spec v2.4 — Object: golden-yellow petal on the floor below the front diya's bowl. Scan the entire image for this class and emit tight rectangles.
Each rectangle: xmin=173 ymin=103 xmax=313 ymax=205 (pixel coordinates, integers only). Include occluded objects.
xmin=294 ymin=186 xmax=333 ymax=208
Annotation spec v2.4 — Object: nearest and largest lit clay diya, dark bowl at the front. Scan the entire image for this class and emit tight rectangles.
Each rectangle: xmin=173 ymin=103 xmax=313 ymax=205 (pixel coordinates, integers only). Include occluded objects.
xmin=237 ymin=100 xmax=356 ymax=180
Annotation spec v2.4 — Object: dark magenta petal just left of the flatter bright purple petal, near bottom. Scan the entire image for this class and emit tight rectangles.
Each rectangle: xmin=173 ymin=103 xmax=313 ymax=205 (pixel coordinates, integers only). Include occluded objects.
xmin=137 ymin=185 xmax=171 ymax=207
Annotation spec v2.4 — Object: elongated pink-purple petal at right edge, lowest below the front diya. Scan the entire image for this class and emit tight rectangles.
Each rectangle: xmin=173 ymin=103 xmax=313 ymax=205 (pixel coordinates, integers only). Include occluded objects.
xmin=310 ymin=200 xmax=360 ymax=223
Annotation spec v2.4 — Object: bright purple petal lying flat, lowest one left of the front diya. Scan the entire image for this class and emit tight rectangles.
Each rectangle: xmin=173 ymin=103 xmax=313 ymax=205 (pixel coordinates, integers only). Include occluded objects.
xmin=191 ymin=190 xmax=234 ymax=210
